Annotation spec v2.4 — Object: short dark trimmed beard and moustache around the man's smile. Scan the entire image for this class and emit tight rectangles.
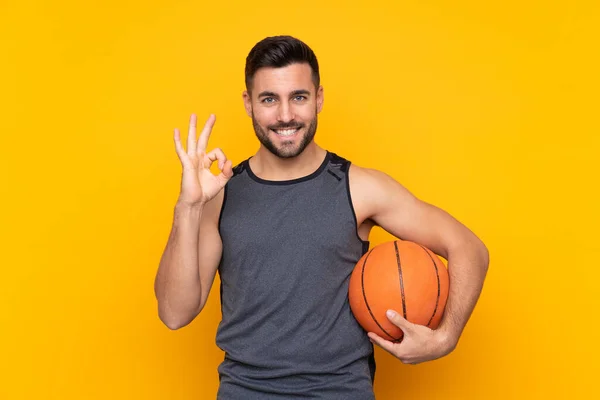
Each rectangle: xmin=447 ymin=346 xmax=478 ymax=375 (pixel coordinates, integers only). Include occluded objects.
xmin=252 ymin=112 xmax=318 ymax=158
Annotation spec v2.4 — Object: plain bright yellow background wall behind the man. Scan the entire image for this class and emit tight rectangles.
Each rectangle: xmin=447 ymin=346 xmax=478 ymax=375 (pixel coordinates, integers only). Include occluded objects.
xmin=0 ymin=0 xmax=600 ymax=400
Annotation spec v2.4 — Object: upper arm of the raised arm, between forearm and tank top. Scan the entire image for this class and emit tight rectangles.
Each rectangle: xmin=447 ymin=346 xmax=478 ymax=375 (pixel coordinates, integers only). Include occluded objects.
xmin=198 ymin=191 xmax=223 ymax=311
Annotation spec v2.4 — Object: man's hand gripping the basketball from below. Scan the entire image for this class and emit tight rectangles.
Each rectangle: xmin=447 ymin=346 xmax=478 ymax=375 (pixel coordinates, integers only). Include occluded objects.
xmin=368 ymin=310 xmax=456 ymax=365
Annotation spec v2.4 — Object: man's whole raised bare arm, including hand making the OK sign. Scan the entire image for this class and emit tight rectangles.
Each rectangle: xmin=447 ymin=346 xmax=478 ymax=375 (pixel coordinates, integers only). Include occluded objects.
xmin=154 ymin=115 xmax=233 ymax=329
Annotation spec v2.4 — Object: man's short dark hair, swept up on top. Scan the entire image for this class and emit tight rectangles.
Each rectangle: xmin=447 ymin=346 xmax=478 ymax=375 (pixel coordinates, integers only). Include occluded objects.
xmin=246 ymin=36 xmax=321 ymax=92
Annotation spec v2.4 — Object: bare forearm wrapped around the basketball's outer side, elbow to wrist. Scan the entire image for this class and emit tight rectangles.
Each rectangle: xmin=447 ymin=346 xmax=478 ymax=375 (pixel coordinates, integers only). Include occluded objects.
xmin=438 ymin=243 xmax=489 ymax=346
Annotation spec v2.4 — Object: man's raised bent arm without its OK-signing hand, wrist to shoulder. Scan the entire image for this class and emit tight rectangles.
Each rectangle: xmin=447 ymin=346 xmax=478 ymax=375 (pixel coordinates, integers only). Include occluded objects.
xmin=154 ymin=190 xmax=223 ymax=329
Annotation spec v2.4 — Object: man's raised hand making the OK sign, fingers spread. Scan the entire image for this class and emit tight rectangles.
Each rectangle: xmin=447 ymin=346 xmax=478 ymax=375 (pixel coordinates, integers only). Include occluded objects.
xmin=174 ymin=114 xmax=233 ymax=205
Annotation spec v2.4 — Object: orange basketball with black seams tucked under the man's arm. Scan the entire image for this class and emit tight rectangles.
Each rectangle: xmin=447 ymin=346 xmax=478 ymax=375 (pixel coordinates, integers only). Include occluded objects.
xmin=348 ymin=240 xmax=449 ymax=342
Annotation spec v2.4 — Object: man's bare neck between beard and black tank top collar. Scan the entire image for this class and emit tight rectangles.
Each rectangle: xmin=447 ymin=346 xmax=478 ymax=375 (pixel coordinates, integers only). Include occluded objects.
xmin=249 ymin=142 xmax=327 ymax=181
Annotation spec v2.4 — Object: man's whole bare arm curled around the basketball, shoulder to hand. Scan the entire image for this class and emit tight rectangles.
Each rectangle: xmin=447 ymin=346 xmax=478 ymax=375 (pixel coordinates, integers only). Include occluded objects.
xmin=355 ymin=169 xmax=489 ymax=364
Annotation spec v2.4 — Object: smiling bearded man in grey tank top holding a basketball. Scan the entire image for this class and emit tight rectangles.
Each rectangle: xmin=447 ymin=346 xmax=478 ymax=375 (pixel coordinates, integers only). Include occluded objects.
xmin=155 ymin=36 xmax=488 ymax=400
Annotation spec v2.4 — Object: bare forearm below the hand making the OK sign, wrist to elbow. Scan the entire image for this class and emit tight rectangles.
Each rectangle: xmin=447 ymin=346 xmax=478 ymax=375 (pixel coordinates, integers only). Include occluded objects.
xmin=154 ymin=203 xmax=203 ymax=328
